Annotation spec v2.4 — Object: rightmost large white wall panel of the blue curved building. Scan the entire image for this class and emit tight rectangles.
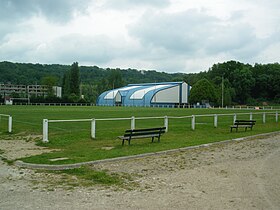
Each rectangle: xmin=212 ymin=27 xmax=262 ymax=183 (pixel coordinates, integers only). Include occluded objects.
xmin=152 ymin=86 xmax=180 ymax=103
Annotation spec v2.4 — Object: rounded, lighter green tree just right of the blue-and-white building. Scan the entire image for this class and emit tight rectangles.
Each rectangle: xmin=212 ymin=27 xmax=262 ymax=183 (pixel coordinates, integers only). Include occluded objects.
xmin=189 ymin=79 xmax=217 ymax=104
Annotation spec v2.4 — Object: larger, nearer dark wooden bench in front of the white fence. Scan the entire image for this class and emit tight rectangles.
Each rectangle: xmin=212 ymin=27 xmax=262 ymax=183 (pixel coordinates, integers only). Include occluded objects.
xmin=118 ymin=127 xmax=166 ymax=145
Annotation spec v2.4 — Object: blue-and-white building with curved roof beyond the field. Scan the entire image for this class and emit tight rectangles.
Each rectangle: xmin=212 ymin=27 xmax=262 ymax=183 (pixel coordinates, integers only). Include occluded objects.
xmin=97 ymin=82 xmax=191 ymax=107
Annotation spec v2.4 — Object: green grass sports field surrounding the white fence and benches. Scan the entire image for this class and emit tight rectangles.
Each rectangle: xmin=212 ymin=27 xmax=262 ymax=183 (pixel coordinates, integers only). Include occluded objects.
xmin=0 ymin=106 xmax=280 ymax=164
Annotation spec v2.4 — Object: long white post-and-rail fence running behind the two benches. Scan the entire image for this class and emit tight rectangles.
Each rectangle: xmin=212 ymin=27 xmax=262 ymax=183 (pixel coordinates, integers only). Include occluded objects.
xmin=43 ymin=111 xmax=279 ymax=143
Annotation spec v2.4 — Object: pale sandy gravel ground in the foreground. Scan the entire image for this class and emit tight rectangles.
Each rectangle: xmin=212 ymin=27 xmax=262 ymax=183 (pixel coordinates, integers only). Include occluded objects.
xmin=0 ymin=133 xmax=280 ymax=210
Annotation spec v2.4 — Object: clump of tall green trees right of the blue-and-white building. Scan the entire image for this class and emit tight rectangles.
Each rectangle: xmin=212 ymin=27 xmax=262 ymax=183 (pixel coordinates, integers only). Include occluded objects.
xmin=185 ymin=61 xmax=280 ymax=106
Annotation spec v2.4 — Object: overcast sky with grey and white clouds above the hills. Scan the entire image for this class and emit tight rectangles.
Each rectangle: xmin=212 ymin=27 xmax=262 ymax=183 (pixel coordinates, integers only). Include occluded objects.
xmin=0 ymin=0 xmax=280 ymax=73
